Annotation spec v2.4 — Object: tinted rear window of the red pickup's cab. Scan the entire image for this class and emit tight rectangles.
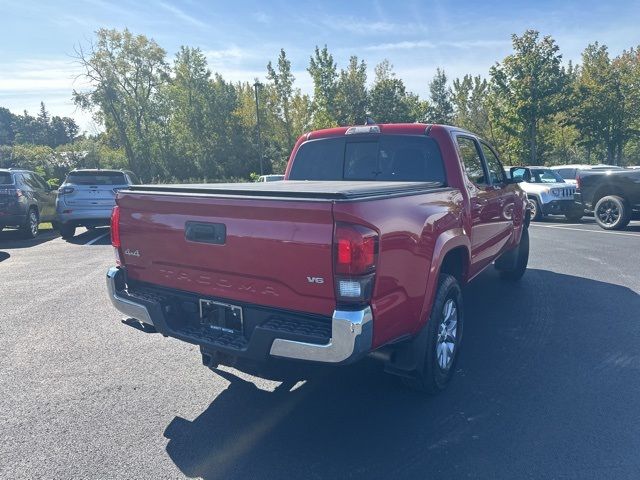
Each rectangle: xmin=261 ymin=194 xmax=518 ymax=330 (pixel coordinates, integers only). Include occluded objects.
xmin=289 ymin=135 xmax=445 ymax=183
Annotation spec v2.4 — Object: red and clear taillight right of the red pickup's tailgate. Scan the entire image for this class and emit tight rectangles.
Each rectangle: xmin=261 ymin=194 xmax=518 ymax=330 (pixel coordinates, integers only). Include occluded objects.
xmin=334 ymin=223 xmax=378 ymax=303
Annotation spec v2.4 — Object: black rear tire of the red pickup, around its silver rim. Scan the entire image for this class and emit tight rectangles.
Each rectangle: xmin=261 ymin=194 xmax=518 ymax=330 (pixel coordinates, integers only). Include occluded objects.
xmin=402 ymin=273 xmax=464 ymax=395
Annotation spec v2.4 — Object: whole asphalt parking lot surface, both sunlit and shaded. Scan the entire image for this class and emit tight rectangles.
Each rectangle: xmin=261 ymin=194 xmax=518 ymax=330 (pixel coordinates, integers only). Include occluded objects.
xmin=0 ymin=218 xmax=640 ymax=479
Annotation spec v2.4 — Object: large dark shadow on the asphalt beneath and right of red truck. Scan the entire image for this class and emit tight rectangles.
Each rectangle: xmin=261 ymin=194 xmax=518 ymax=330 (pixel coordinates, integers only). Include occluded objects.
xmin=164 ymin=269 xmax=640 ymax=479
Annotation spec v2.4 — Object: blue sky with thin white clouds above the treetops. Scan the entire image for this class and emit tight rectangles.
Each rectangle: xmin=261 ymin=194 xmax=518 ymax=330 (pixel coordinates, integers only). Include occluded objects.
xmin=0 ymin=0 xmax=640 ymax=132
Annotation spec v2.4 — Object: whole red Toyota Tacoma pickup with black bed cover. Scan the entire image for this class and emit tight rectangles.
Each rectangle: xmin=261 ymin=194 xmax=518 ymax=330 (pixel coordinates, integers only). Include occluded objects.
xmin=107 ymin=124 xmax=529 ymax=393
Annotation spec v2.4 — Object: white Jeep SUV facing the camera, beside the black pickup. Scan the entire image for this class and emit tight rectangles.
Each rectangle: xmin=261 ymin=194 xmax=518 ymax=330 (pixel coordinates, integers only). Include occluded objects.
xmin=509 ymin=166 xmax=584 ymax=222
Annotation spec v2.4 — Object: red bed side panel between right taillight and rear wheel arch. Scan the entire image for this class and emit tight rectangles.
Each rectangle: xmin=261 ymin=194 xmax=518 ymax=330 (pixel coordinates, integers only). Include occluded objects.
xmin=334 ymin=189 xmax=463 ymax=348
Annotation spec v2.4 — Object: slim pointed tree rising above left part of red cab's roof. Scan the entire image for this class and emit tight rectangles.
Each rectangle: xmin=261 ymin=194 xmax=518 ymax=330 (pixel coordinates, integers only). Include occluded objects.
xmin=307 ymin=45 xmax=338 ymax=129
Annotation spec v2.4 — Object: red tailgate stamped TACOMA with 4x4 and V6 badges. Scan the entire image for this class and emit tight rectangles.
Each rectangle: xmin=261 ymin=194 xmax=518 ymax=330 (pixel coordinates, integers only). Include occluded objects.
xmin=117 ymin=192 xmax=335 ymax=315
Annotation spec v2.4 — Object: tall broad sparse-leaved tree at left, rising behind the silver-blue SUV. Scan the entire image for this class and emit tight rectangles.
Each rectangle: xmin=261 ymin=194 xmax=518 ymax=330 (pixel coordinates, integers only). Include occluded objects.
xmin=73 ymin=29 xmax=169 ymax=180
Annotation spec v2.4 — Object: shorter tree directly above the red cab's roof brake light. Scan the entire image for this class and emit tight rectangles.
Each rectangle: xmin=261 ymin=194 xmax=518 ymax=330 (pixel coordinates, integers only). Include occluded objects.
xmin=336 ymin=56 xmax=369 ymax=125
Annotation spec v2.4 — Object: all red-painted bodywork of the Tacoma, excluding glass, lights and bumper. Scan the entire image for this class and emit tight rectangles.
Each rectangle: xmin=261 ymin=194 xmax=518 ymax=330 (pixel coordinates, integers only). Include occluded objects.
xmin=117 ymin=124 xmax=525 ymax=348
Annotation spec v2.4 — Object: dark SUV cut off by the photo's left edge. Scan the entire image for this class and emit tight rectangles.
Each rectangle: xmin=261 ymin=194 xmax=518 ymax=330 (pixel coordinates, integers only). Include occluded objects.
xmin=0 ymin=168 xmax=56 ymax=238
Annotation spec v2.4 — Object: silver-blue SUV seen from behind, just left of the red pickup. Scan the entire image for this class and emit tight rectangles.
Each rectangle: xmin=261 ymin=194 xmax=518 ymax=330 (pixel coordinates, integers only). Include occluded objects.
xmin=56 ymin=169 xmax=140 ymax=238
